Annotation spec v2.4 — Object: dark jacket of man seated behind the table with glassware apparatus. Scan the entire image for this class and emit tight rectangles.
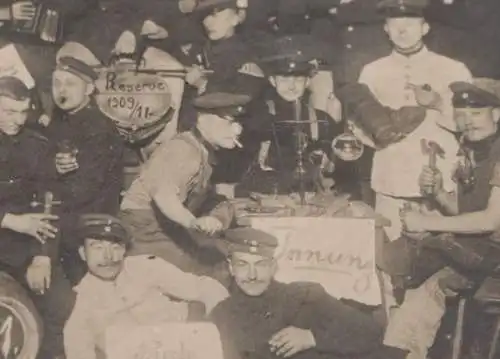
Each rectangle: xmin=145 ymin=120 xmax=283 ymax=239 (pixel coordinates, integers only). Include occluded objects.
xmin=233 ymin=89 xmax=354 ymax=194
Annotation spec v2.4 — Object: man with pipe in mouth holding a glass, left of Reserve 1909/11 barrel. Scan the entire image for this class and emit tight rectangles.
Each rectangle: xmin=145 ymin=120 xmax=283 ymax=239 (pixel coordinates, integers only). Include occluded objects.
xmin=46 ymin=56 xmax=124 ymax=281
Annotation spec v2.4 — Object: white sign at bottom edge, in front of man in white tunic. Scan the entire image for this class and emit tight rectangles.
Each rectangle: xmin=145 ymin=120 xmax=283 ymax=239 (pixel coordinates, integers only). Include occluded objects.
xmin=106 ymin=323 xmax=223 ymax=359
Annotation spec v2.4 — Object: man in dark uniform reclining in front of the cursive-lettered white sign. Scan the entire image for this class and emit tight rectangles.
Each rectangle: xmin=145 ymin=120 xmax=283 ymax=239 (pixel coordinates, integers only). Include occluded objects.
xmin=211 ymin=228 xmax=406 ymax=359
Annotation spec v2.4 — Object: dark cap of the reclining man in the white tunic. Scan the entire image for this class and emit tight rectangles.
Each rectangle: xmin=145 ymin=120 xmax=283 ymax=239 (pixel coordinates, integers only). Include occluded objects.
xmin=77 ymin=213 xmax=131 ymax=248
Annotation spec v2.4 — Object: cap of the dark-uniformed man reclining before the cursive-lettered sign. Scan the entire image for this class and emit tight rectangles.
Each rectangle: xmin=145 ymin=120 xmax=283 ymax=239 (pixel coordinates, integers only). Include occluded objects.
xmin=217 ymin=227 xmax=278 ymax=258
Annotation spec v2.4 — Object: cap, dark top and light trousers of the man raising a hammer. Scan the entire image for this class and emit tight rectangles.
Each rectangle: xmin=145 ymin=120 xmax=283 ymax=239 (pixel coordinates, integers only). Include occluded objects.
xmin=384 ymin=82 xmax=500 ymax=359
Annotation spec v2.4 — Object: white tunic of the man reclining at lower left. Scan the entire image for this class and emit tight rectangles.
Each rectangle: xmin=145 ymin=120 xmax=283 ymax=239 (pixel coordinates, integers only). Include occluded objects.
xmin=64 ymin=256 xmax=228 ymax=359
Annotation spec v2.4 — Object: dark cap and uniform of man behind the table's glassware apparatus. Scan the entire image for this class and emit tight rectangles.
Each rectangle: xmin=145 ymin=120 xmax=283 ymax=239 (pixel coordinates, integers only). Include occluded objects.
xmin=239 ymin=34 xmax=347 ymax=193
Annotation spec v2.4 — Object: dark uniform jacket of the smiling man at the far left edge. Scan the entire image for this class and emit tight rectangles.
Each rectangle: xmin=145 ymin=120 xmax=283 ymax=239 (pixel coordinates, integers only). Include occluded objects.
xmin=0 ymin=129 xmax=55 ymax=269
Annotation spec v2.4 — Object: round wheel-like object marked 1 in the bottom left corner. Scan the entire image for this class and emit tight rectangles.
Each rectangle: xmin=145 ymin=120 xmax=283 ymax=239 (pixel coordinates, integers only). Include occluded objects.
xmin=0 ymin=272 xmax=43 ymax=359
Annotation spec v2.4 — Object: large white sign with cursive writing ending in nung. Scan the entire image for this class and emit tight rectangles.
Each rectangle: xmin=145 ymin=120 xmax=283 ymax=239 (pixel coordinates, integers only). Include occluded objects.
xmin=251 ymin=217 xmax=382 ymax=305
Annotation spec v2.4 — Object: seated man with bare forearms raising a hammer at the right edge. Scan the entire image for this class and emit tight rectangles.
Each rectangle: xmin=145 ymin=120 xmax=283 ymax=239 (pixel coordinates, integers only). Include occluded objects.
xmin=385 ymin=82 xmax=500 ymax=359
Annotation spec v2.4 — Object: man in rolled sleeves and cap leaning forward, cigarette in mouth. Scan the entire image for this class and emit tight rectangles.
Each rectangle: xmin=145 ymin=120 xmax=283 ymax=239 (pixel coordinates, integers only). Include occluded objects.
xmin=121 ymin=86 xmax=250 ymax=282
